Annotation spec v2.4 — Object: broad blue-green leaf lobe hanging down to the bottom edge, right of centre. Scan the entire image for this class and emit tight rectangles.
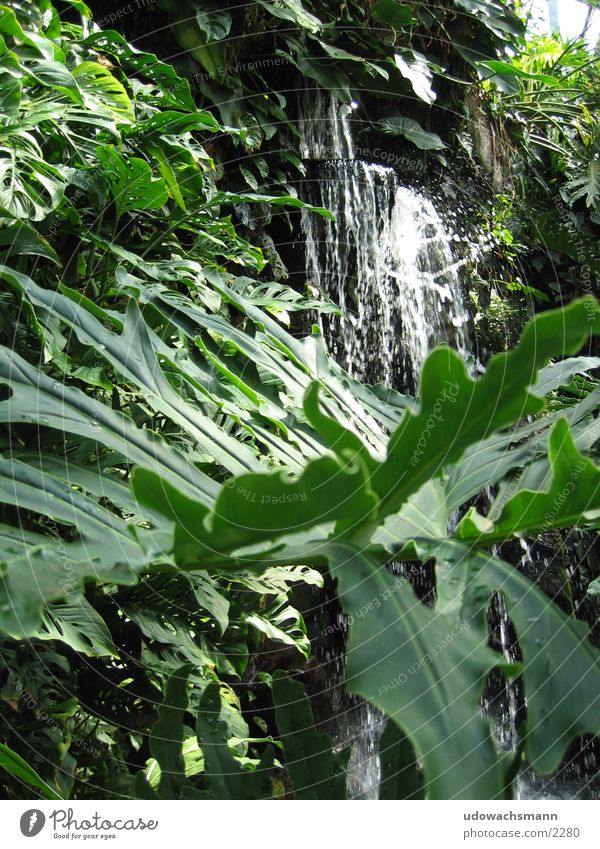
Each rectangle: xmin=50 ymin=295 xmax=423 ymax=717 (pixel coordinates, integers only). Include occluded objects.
xmin=328 ymin=543 xmax=504 ymax=799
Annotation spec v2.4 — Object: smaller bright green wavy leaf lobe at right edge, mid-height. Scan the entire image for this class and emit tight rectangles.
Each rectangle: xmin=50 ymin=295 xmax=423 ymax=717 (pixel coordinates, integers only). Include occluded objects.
xmin=456 ymin=419 xmax=600 ymax=545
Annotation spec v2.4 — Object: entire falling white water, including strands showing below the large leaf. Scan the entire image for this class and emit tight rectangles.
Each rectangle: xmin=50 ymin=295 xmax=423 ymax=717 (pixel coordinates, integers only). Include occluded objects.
xmin=300 ymin=91 xmax=595 ymax=799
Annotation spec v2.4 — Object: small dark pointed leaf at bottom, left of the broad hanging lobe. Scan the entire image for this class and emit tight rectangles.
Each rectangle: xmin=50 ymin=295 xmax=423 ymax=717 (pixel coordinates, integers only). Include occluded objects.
xmin=379 ymin=719 xmax=424 ymax=800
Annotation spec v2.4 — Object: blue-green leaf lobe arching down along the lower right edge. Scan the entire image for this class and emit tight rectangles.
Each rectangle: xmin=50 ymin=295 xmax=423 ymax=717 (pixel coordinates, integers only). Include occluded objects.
xmin=423 ymin=541 xmax=600 ymax=775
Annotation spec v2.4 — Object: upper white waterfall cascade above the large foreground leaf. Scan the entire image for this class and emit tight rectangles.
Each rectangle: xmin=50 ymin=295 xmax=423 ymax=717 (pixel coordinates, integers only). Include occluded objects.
xmin=301 ymin=93 xmax=469 ymax=389
